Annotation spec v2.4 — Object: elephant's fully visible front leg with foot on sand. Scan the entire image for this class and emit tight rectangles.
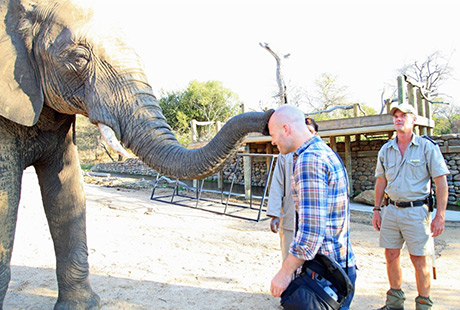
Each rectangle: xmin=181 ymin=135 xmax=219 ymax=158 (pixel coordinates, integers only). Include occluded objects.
xmin=35 ymin=136 xmax=100 ymax=310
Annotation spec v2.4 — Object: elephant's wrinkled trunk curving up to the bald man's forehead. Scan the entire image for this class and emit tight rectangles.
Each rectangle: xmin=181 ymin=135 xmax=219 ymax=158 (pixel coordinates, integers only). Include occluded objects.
xmin=121 ymin=102 xmax=273 ymax=179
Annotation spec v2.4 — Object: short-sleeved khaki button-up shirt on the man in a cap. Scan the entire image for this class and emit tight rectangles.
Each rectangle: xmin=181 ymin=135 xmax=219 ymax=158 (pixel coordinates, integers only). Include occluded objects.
xmin=375 ymin=134 xmax=449 ymax=202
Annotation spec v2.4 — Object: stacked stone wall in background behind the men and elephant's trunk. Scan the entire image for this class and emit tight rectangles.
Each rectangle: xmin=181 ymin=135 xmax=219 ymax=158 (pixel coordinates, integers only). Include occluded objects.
xmin=91 ymin=134 xmax=460 ymax=204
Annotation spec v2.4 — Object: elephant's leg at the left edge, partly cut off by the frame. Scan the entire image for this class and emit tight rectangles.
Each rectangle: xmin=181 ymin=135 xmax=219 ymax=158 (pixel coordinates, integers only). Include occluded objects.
xmin=0 ymin=156 xmax=22 ymax=309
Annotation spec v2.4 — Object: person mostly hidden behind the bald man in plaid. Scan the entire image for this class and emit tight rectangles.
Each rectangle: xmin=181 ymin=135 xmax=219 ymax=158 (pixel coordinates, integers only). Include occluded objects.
xmin=267 ymin=117 xmax=318 ymax=261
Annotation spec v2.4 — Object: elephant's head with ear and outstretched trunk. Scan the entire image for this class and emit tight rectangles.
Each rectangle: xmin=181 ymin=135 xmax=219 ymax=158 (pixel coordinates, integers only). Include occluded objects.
xmin=0 ymin=1 xmax=271 ymax=179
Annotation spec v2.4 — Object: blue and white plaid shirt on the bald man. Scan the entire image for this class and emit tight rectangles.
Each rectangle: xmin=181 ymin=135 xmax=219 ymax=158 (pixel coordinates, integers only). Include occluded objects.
xmin=290 ymin=136 xmax=356 ymax=267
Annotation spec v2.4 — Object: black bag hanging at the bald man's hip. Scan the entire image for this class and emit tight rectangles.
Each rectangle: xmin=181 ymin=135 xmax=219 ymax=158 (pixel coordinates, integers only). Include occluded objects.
xmin=281 ymin=254 xmax=354 ymax=310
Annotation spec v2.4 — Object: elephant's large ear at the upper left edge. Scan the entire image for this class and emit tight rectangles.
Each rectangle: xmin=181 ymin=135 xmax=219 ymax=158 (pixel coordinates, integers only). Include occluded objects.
xmin=0 ymin=0 xmax=43 ymax=126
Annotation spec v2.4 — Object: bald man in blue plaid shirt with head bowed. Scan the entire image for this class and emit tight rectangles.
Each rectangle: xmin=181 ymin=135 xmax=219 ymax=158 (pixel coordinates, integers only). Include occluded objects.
xmin=268 ymin=105 xmax=356 ymax=309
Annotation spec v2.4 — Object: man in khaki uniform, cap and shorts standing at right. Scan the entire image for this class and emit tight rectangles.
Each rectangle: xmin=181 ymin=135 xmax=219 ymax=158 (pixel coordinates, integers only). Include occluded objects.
xmin=372 ymin=104 xmax=449 ymax=310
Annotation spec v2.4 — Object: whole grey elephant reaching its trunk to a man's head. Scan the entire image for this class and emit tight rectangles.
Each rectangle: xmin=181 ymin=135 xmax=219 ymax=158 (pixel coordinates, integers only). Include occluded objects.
xmin=0 ymin=0 xmax=273 ymax=309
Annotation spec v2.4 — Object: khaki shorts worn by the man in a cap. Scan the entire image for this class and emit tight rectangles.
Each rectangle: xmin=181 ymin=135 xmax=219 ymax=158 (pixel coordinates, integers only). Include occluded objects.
xmin=379 ymin=204 xmax=433 ymax=256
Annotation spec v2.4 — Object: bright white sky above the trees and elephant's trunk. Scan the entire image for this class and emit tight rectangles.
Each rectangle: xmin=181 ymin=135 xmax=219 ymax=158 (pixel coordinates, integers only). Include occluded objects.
xmin=92 ymin=0 xmax=460 ymax=111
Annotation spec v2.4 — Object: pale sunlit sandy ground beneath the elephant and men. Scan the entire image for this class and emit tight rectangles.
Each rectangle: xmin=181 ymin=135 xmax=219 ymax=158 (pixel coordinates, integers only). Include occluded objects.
xmin=4 ymin=170 xmax=460 ymax=310
